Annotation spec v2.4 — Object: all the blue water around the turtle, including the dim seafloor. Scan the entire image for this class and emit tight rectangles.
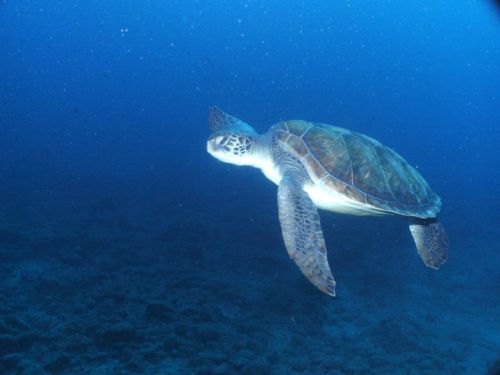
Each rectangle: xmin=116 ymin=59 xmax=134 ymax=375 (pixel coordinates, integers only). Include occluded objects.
xmin=0 ymin=0 xmax=500 ymax=374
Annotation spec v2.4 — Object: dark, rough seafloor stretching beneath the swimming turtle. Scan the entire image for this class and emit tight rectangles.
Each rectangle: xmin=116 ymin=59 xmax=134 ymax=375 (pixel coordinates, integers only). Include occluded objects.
xmin=0 ymin=194 xmax=500 ymax=374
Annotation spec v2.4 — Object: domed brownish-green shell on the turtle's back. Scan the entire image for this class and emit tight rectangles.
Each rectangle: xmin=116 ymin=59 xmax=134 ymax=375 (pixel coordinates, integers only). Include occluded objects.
xmin=274 ymin=120 xmax=441 ymax=218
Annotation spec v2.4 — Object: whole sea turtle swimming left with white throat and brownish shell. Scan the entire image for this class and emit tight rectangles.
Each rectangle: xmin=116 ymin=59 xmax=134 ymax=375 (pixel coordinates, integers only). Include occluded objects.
xmin=207 ymin=107 xmax=448 ymax=296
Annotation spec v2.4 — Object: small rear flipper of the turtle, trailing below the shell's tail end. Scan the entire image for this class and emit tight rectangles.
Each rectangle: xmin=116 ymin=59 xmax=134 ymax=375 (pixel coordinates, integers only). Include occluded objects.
xmin=410 ymin=218 xmax=448 ymax=270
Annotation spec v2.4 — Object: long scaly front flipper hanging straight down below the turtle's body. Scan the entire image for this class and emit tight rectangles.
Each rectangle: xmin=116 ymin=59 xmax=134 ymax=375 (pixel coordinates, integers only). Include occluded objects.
xmin=278 ymin=173 xmax=335 ymax=296
